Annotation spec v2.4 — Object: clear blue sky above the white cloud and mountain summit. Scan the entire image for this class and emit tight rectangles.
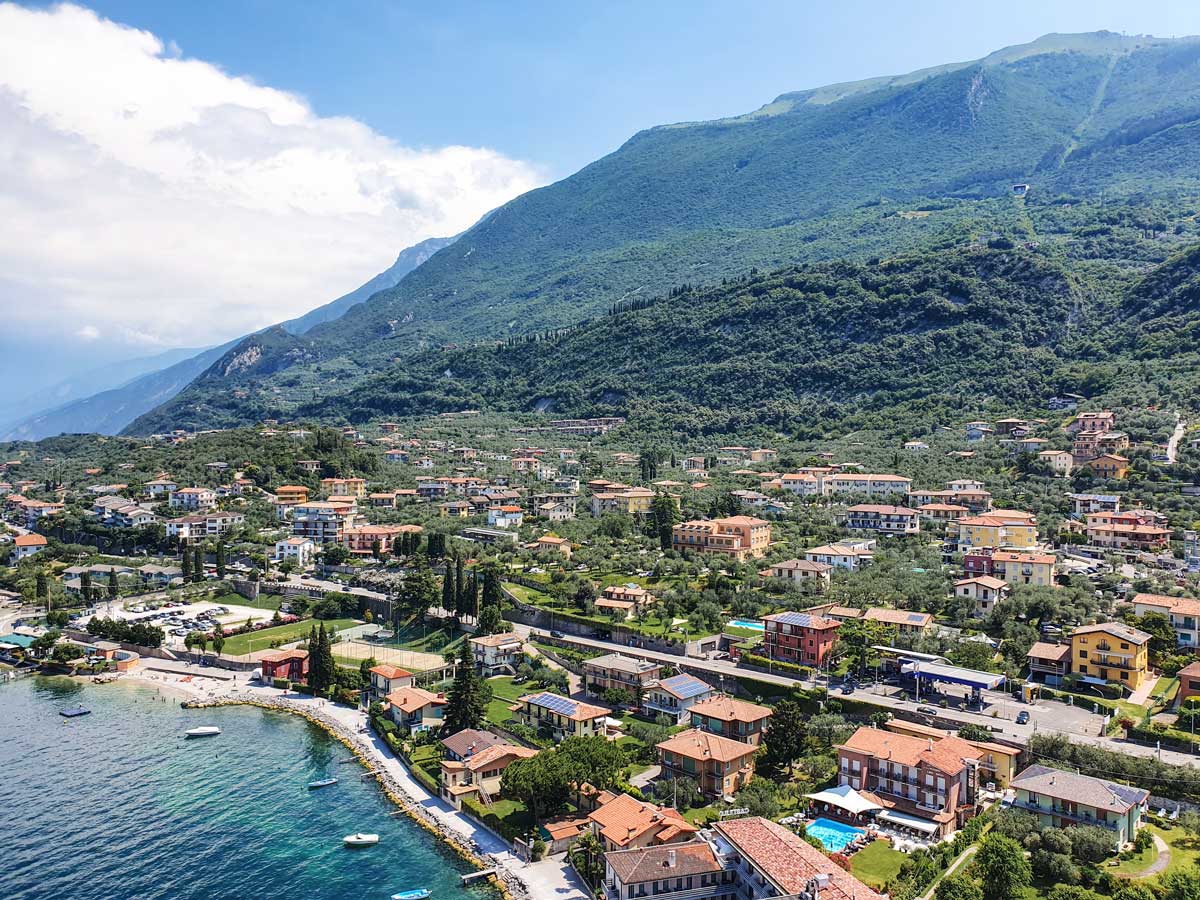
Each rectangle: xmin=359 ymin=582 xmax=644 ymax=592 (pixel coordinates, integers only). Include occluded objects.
xmin=70 ymin=0 xmax=1200 ymax=178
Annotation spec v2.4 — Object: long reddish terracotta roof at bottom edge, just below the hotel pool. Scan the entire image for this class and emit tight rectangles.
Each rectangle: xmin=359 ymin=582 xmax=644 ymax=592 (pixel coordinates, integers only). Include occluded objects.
xmin=713 ymin=816 xmax=882 ymax=900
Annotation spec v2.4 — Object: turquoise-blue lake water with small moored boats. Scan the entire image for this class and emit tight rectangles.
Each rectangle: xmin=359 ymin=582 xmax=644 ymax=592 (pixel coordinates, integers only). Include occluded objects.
xmin=0 ymin=678 xmax=494 ymax=900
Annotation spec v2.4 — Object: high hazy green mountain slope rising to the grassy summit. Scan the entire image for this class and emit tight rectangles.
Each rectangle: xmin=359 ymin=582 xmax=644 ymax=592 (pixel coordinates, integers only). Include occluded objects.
xmin=131 ymin=32 xmax=1200 ymax=433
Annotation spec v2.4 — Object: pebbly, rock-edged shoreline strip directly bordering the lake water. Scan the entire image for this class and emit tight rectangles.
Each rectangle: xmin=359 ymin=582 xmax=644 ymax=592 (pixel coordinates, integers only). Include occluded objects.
xmin=113 ymin=672 xmax=549 ymax=900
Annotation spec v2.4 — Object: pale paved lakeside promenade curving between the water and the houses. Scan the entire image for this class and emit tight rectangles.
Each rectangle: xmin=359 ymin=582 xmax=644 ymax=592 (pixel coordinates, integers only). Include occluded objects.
xmin=133 ymin=666 xmax=589 ymax=900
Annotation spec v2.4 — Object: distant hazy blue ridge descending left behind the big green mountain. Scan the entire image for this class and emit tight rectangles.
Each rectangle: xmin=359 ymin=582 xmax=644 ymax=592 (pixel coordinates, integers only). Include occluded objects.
xmin=0 ymin=238 xmax=457 ymax=440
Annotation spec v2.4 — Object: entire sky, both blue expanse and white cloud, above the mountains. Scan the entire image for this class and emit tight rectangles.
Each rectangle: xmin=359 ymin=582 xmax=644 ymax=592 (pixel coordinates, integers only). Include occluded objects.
xmin=0 ymin=0 xmax=1200 ymax=415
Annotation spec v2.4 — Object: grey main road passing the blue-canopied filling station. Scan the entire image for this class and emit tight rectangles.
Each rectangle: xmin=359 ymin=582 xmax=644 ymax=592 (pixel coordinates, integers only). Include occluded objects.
xmin=515 ymin=625 xmax=1200 ymax=766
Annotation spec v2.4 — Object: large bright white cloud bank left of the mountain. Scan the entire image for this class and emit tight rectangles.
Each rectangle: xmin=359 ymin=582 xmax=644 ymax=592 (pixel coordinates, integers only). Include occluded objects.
xmin=0 ymin=4 xmax=539 ymax=355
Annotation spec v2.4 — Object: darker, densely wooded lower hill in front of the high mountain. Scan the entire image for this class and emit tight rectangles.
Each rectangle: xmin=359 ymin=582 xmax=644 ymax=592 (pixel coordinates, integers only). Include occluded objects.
xmin=301 ymin=248 xmax=1200 ymax=437
